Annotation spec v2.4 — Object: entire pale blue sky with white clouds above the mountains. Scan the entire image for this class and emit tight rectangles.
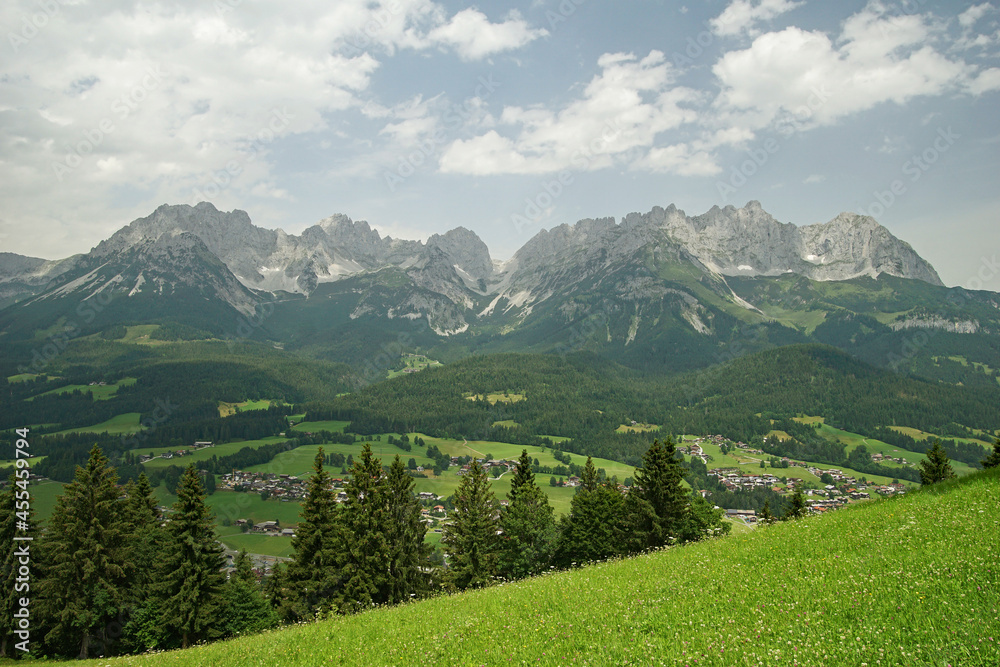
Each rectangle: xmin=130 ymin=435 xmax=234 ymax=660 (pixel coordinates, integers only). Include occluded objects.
xmin=0 ymin=0 xmax=1000 ymax=291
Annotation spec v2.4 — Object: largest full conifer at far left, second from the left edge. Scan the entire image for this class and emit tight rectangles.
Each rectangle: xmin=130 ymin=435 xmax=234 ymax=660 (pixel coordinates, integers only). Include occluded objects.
xmin=40 ymin=445 xmax=129 ymax=659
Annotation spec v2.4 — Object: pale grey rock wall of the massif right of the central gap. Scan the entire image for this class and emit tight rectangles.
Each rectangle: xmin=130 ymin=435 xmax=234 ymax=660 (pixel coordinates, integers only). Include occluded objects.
xmin=497 ymin=201 xmax=941 ymax=316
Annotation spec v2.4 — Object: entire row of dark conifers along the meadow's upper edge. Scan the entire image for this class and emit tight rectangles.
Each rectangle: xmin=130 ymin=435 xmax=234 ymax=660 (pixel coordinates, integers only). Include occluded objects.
xmin=0 ymin=439 xmax=728 ymax=658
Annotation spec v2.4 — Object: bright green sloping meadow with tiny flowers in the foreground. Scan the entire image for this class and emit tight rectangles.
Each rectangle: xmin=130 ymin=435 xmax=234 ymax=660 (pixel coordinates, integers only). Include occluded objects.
xmin=58 ymin=470 xmax=1000 ymax=667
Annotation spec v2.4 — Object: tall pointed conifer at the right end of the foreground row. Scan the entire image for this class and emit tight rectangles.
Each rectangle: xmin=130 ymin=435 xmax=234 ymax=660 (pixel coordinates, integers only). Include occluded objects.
xmin=623 ymin=436 xmax=691 ymax=552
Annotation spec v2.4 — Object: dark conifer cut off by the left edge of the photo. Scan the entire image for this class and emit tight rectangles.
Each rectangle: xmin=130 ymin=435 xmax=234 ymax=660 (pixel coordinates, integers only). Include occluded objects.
xmin=0 ymin=468 xmax=40 ymax=658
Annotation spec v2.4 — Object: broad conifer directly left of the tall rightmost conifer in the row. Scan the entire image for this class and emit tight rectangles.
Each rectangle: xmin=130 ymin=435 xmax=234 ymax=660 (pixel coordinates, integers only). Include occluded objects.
xmin=553 ymin=457 xmax=624 ymax=567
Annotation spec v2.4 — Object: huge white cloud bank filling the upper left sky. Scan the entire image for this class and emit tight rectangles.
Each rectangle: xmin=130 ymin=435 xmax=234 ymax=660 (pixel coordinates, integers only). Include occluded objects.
xmin=0 ymin=0 xmax=541 ymax=253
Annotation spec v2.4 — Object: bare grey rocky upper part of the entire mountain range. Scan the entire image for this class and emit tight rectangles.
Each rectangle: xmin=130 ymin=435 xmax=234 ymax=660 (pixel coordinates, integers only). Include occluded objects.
xmin=0 ymin=201 xmax=941 ymax=335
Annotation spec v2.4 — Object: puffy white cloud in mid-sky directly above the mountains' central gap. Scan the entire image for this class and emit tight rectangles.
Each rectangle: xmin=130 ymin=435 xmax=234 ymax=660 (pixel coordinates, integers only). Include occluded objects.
xmin=441 ymin=51 xmax=697 ymax=175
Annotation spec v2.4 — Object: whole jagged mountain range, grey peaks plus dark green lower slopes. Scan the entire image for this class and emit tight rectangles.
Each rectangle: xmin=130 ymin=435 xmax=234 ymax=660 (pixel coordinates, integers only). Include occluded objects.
xmin=0 ymin=201 xmax=1000 ymax=383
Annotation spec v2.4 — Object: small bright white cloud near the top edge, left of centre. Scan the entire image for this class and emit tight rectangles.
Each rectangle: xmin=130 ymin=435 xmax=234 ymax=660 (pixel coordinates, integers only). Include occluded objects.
xmin=427 ymin=8 xmax=549 ymax=60
